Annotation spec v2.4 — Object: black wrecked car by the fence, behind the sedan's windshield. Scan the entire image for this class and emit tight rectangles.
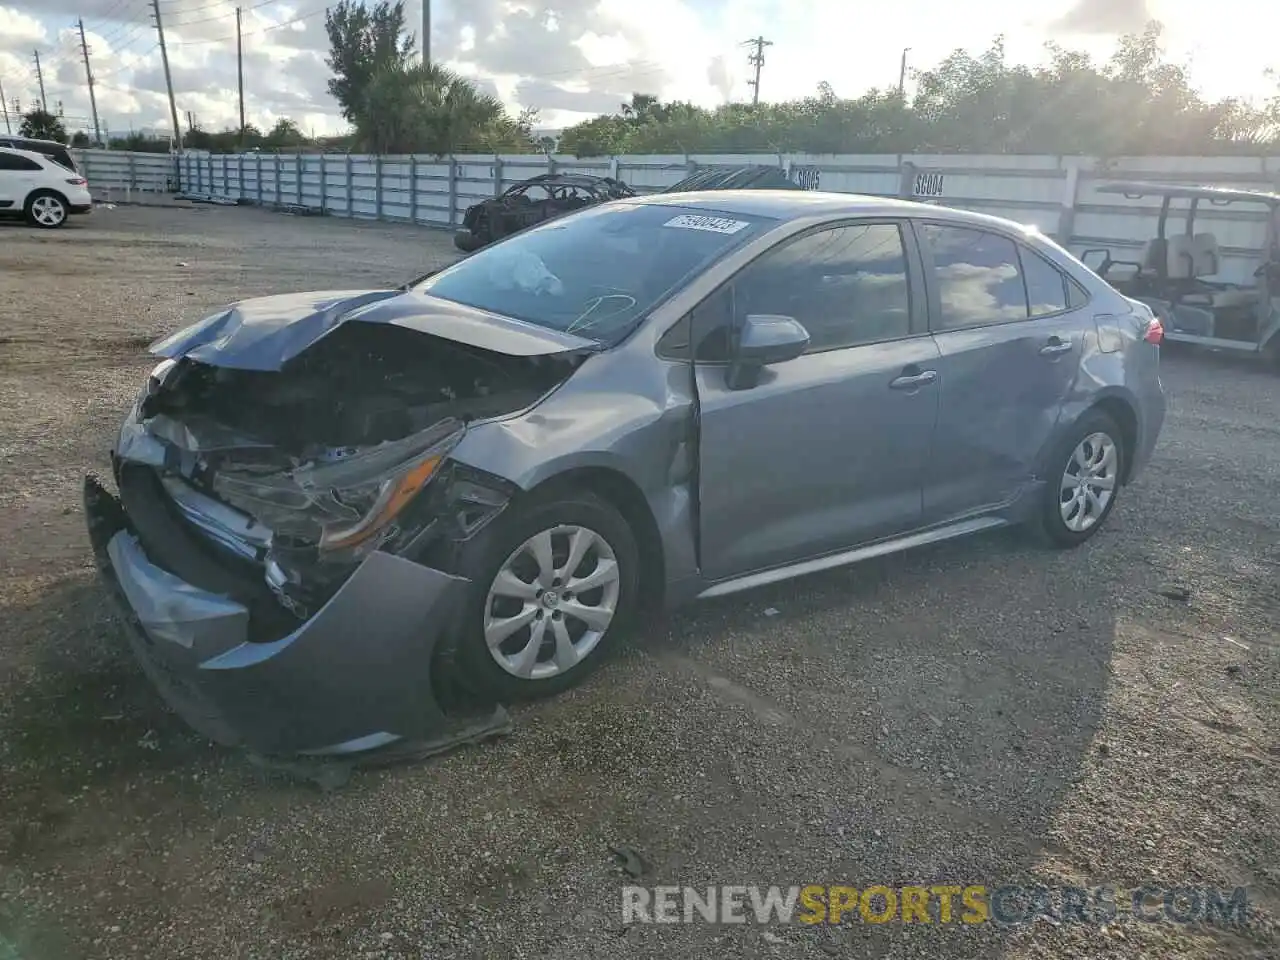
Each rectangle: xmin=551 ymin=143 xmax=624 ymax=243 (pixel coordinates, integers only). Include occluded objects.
xmin=453 ymin=173 xmax=636 ymax=253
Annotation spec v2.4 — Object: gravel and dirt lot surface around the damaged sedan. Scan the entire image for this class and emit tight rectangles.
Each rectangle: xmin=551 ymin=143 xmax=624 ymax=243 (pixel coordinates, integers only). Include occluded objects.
xmin=0 ymin=207 xmax=1280 ymax=960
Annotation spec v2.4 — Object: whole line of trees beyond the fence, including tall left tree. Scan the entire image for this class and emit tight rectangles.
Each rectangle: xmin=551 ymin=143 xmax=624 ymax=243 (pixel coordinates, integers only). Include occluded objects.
xmin=23 ymin=15 xmax=1280 ymax=156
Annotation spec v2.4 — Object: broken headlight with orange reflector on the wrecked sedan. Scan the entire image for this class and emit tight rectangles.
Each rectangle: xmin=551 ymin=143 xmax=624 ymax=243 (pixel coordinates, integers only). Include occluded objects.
xmin=212 ymin=420 xmax=466 ymax=559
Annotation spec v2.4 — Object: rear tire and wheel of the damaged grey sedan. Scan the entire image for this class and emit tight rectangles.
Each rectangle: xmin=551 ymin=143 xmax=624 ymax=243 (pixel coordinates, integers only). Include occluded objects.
xmin=1033 ymin=410 xmax=1129 ymax=548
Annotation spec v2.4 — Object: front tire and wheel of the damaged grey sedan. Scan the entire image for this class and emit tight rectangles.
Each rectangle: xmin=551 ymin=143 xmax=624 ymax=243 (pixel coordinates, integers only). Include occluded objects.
xmin=447 ymin=489 xmax=640 ymax=703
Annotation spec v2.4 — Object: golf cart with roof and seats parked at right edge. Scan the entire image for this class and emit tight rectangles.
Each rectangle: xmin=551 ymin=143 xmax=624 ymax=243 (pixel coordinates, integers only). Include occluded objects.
xmin=1080 ymin=180 xmax=1280 ymax=360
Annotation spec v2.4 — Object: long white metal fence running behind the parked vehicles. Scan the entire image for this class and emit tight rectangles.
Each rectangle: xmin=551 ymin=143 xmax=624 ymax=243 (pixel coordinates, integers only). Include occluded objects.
xmin=72 ymin=151 xmax=1280 ymax=280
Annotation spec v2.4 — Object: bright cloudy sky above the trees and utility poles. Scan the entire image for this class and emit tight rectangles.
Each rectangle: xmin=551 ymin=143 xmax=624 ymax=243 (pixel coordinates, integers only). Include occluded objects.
xmin=0 ymin=0 xmax=1280 ymax=142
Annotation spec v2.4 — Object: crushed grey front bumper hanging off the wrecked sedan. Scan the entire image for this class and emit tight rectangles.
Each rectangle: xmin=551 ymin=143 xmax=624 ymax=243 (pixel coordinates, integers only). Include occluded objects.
xmin=84 ymin=476 xmax=509 ymax=755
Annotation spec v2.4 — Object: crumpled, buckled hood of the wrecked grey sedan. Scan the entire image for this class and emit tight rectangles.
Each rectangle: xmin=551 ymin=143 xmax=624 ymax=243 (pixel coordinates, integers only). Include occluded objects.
xmin=150 ymin=291 xmax=598 ymax=370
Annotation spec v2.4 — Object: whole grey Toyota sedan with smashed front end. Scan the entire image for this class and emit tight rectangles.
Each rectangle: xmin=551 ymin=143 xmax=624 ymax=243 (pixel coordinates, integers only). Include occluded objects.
xmin=84 ymin=191 xmax=1164 ymax=754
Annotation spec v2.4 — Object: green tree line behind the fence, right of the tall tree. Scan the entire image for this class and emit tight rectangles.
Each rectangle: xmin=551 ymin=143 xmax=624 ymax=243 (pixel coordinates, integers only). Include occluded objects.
xmin=559 ymin=23 xmax=1280 ymax=156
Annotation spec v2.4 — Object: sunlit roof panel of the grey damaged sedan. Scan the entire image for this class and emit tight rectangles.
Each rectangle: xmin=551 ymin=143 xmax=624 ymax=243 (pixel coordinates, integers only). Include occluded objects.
xmin=617 ymin=189 xmax=1028 ymax=229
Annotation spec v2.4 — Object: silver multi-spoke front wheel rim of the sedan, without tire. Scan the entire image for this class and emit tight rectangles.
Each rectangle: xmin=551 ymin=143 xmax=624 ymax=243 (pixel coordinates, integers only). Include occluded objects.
xmin=484 ymin=524 xmax=622 ymax=680
